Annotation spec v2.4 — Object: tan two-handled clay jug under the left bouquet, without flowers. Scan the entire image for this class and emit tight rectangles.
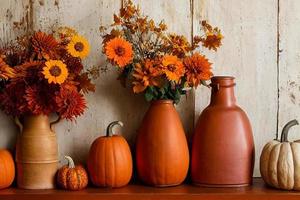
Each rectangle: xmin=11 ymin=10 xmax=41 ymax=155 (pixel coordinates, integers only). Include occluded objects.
xmin=16 ymin=115 xmax=58 ymax=189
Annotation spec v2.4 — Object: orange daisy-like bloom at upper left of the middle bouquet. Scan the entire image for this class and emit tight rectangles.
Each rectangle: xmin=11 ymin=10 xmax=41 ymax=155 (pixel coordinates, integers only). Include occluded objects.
xmin=105 ymin=38 xmax=133 ymax=67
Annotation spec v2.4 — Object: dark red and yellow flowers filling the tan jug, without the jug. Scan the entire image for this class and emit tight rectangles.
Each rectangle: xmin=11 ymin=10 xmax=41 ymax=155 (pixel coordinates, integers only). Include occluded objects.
xmin=0 ymin=27 xmax=95 ymax=120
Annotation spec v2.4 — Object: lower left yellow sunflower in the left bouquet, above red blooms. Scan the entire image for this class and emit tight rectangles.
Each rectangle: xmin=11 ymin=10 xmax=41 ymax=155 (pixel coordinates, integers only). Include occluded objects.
xmin=42 ymin=60 xmax=69 ymax=84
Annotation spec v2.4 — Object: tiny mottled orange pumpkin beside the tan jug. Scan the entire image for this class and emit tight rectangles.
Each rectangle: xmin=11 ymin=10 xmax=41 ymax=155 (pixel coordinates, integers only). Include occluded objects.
xmin=57 ymin=156 xmax=88 ymax=190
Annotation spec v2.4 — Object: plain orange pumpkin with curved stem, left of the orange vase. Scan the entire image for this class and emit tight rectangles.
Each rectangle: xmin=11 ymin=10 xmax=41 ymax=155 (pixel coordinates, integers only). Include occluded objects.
xmin=88 ymin=121 xmax=132 ymax=187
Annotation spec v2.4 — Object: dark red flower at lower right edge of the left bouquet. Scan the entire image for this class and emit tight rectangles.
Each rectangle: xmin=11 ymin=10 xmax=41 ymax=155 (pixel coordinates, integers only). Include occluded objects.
xmin=55 ymin=89 xmax=86 ymax=121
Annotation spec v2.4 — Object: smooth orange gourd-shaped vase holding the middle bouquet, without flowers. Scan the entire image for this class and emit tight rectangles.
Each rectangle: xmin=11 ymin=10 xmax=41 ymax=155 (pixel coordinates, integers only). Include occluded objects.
xmin=136 ymin=100 xmax=189 ymax=187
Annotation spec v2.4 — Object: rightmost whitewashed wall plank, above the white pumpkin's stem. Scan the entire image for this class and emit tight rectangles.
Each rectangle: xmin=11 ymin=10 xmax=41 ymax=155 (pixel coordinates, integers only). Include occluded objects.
xmin=278 ymin=0 xmax=300 ymax=141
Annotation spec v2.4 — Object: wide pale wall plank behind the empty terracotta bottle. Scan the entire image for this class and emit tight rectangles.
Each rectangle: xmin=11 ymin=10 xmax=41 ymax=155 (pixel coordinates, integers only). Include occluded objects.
xmin=194 ymin=0 xmax=278 ymax=176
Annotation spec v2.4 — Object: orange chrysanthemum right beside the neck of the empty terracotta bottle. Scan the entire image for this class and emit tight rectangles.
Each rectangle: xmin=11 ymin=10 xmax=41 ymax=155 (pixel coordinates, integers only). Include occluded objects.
xmin=183 ymin=53 xmax=213 ymax=87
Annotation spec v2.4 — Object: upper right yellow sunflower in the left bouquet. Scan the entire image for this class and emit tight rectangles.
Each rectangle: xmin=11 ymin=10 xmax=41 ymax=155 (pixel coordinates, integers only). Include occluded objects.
xmin=67 ymin=35 xmax=90 ymax=59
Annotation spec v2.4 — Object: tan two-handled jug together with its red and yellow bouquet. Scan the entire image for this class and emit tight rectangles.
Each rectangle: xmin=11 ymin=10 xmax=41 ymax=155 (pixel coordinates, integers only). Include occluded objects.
xmin=0 ymin=27 xmax=95 ymax=189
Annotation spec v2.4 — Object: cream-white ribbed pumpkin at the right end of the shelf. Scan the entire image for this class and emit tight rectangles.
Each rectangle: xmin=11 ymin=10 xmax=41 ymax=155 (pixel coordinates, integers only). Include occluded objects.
xmin=260 ymin=120 xmax=300 ymax=190
